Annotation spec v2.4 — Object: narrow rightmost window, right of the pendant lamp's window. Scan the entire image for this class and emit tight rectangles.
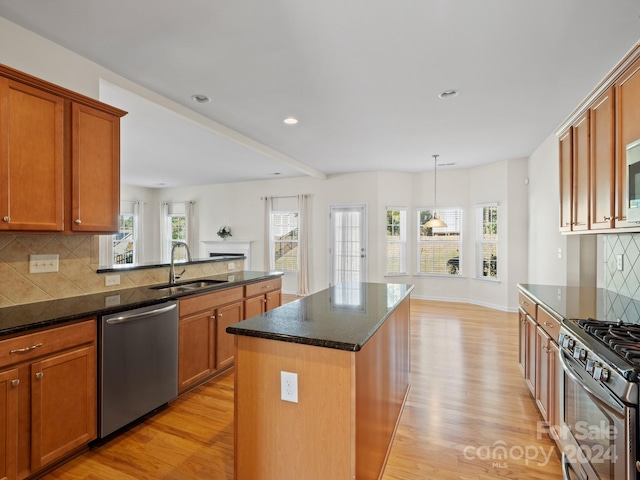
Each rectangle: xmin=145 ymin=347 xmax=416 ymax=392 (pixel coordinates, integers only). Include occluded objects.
xmin=476 ymin=203 xmax=498 ymax=279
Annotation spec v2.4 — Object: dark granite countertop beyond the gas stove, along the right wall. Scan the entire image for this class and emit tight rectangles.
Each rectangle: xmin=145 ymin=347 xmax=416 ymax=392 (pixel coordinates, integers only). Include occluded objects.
xmin=518 ymin=283 xmax=640 ymax=323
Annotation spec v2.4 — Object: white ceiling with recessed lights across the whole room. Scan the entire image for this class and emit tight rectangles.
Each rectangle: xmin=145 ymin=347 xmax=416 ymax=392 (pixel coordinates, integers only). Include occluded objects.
xmin=0 ymin=0 xmax=640 ymax=186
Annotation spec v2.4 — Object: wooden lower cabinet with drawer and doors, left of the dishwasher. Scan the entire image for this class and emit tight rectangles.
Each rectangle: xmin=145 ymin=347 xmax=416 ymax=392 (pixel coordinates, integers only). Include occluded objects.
xmin=0 ymin=319 xmax=97 ymax=480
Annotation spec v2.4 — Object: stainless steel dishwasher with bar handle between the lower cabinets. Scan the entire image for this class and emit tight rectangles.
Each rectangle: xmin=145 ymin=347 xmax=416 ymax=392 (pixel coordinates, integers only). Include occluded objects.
xmin=98 ymin=301 xmax=178 ymax=438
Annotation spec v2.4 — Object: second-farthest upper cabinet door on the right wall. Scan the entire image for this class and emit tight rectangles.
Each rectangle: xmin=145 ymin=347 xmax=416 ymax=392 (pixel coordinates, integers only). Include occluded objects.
xmin=571 ymin=111 xmax=590 ymax=231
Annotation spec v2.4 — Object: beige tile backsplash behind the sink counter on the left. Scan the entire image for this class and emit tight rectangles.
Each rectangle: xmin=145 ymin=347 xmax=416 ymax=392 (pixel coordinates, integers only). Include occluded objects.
xmin=0 ymin=235 xmax=244 ymax=307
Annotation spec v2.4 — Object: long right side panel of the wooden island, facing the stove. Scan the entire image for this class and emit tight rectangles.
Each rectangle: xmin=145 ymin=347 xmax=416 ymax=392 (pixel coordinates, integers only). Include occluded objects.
xmin=356 ymin=297 xmax=410 ymax=480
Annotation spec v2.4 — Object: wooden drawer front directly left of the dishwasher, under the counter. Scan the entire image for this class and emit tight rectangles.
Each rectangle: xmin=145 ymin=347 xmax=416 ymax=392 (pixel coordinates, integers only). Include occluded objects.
xmin=0 ymin=319 xmax=96 ymax=367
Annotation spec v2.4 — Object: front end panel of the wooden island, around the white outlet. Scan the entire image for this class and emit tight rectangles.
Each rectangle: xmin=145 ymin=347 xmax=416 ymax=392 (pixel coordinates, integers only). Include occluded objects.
xmin=235 ymin=335 xmax=356 ymax=480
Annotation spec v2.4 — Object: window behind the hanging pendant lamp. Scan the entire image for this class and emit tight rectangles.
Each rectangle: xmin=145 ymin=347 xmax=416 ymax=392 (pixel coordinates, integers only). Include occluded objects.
xmin=418 ymin=208 xmax=462 ymax=275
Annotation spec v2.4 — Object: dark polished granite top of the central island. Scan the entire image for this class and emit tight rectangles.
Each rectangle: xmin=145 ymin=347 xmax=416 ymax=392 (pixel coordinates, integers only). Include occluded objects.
xmin=227 ymin=283 xmax=413 ymax=352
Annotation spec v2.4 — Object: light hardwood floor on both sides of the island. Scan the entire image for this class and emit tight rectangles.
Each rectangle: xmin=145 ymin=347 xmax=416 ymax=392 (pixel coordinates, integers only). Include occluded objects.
xmin=44 ymin=299 xmax=562 ymax=480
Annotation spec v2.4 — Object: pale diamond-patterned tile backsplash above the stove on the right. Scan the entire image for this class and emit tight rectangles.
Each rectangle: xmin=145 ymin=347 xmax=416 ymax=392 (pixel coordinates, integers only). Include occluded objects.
xmin=603 ymin=233 xmax=640 ymax=300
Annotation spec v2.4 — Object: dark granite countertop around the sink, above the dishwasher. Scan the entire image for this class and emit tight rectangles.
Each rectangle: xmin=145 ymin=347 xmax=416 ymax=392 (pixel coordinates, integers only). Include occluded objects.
xmin=0 ymin=271 xmax=282 ymax=336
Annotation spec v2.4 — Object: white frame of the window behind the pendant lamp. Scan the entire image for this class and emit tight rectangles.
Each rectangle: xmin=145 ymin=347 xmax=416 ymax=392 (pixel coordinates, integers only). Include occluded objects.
xmin=416 ymin=207 xmax=464 ymax=278
